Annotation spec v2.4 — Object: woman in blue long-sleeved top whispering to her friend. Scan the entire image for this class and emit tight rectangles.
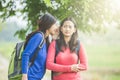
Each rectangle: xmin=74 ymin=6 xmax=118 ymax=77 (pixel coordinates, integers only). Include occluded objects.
xmin=22 ymin=14 xmax=57 ymax=80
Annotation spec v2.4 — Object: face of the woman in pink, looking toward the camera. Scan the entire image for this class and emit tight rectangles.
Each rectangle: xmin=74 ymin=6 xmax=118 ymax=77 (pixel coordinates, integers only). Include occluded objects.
xmin=61 ymin=21 xmax=76 ymax=37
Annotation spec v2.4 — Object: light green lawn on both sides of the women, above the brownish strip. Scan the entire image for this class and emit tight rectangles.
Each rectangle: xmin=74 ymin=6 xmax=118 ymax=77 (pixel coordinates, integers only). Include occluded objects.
xmin=0 ymin=42 xmax=120 ymax=68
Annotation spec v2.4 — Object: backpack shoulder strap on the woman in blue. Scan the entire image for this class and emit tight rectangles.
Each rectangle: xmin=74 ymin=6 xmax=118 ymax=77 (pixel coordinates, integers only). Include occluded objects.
xmin=29 ymin=32 xmax=44 ymax=67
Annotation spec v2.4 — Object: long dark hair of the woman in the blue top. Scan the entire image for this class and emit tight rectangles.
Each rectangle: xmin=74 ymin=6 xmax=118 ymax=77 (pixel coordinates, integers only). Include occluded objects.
xmin=25 ymin=13 xmax=57 ymax=46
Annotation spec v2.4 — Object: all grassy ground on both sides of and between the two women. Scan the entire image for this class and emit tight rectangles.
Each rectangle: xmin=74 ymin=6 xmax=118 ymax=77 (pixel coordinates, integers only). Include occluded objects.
xmin=0 ymin=42 xmax=120 ymax=80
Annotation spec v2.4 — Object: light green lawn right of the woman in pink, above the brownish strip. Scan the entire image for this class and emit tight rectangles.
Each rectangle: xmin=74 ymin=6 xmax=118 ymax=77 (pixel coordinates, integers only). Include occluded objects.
xmin=85 ymin=44 xmax=120 ymax=68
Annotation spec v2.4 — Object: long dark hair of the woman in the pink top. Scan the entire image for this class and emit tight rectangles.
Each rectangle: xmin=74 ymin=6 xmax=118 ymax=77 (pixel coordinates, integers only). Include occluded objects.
xmin=57 ymin=17 xmax=78 ymax=52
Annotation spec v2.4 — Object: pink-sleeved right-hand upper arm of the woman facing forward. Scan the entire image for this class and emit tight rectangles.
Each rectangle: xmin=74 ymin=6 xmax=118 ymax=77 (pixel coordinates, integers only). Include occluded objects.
xmin=79 ymin=43 xmax=88 ymax=71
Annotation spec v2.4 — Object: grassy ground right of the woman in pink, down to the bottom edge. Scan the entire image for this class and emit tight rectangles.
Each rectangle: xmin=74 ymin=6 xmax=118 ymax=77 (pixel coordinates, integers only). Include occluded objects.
xmin=85 ymin=44 xmax=120 ymax=80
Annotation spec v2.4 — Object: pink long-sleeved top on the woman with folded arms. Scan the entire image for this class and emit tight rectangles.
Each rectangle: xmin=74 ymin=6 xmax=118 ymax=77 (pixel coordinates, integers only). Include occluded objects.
xmin=46 ymin=41 xmax=87 ymax=80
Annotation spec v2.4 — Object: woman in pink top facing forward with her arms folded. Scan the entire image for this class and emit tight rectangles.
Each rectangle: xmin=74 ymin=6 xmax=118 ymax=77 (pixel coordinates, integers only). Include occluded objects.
xmin=46 ymin=18 xmax=87 ymax=80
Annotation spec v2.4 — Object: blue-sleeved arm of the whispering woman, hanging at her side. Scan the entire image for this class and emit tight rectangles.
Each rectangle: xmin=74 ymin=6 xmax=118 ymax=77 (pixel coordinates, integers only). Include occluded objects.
xmin=22 ymin=33 xmax=42 ymax=74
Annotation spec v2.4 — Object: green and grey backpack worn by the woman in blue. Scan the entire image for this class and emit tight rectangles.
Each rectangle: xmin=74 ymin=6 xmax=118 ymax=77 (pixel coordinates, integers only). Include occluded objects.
xmin=8 ymin=32 xmax=44 ymax=80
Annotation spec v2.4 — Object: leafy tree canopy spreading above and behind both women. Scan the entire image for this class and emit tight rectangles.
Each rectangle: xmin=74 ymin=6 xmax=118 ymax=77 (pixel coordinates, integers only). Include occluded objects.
xmin=0 ymin=0 xmax=120 ymax=38
